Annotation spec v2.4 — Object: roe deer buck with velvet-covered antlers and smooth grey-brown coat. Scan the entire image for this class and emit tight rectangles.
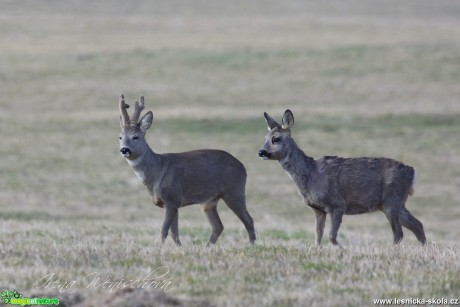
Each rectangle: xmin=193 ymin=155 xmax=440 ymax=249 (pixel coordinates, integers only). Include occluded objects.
xmin=119 ymin=95 xmax=256 ymax=245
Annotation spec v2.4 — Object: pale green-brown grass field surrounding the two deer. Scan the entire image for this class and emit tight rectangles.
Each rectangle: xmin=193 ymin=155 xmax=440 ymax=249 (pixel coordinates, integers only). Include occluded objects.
xmin=0 ymin=0 xmax=460 ymax=306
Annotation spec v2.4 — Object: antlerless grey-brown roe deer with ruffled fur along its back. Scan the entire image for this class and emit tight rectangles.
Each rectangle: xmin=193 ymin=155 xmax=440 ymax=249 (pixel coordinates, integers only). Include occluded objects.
xmin=259 ymin=110 xmax=426 ymax=245
